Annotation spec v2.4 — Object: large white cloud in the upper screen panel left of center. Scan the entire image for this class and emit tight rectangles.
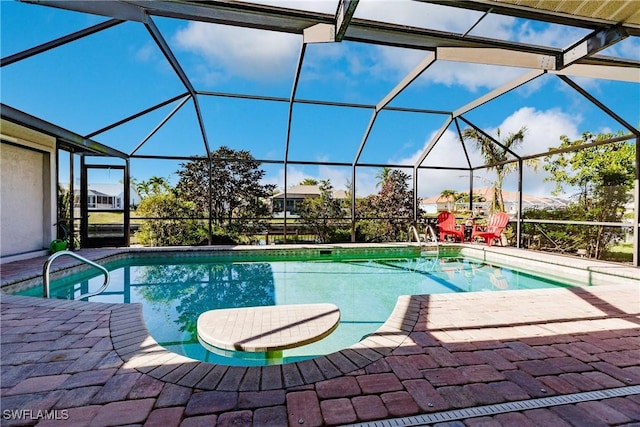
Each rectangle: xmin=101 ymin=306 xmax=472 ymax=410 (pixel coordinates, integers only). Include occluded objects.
xmin=174 ymin=22 xmax=301 ymax=81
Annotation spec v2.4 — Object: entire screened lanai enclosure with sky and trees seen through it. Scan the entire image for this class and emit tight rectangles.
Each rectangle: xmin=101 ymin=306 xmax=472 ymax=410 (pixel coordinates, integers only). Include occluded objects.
xmin=1 ymin=0 xmax=640 ymax=266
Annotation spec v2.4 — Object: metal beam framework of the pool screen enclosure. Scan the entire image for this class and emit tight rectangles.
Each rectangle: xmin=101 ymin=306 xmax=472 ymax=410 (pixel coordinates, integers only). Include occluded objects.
xmin=1 ymin=0 xmax=640 ymax=265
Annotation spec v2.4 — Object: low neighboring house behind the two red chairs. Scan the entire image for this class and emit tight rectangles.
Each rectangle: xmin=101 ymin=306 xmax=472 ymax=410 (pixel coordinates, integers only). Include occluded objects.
xmin=420 ymin=187 xmax=569 ymax=216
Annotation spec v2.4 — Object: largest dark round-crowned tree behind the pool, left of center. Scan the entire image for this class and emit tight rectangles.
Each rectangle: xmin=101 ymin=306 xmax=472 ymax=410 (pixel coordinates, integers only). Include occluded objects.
xmin=176 ymin=146 xmax=276 ymax=232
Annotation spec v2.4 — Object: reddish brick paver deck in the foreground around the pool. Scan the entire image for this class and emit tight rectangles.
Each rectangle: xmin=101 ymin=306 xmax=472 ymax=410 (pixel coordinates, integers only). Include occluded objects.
xmin=0 ymin=249 xmax=640 ymax=427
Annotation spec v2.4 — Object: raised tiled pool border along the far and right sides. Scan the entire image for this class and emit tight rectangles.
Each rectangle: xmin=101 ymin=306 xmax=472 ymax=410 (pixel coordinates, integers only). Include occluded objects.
xmin=0 ymin=242 xmax=640 ymax=294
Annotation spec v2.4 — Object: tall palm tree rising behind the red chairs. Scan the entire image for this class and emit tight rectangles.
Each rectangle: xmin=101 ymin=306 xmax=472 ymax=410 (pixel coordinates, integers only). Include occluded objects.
xmin=462 ymin=126 xmax=537 ymax=212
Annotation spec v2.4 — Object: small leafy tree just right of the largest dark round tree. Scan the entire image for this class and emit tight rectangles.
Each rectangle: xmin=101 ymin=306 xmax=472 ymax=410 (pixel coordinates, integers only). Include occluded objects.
xmin=298 ymin=179 xmax=344 ymax=242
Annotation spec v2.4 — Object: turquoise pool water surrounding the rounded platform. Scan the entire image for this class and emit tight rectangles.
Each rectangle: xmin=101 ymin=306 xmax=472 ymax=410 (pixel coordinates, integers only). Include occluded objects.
xmin=23 ymin=252 xmax=567 ymax=366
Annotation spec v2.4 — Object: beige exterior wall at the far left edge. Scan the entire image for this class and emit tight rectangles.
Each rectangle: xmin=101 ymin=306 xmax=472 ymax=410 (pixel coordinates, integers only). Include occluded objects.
xmin=0 ymin=120 xmax=56 ymax=262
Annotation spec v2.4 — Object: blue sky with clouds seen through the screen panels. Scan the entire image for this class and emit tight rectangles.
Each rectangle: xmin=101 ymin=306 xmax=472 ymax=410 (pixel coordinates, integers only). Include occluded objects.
xmin=0 ymin=0 xmax=640 ymax=196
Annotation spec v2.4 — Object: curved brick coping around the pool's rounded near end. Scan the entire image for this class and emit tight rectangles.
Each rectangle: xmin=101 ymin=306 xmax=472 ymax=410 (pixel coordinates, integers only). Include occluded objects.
xmin=106 ymin=295 xmax=422 ymax=391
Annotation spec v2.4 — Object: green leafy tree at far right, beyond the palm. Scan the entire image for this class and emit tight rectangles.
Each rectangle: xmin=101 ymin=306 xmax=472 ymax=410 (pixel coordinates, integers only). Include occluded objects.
xmin=544 ymin=132 xmax=636 ymax=259
